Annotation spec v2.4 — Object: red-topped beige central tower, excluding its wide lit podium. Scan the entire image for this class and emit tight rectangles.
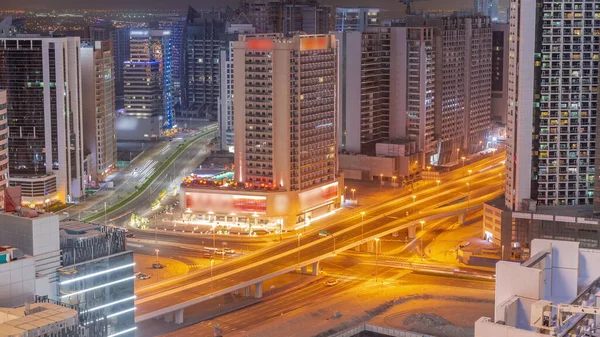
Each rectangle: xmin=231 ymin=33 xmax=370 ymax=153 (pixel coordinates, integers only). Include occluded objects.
xmin=233 ymin=35 xmax=338 ymax=191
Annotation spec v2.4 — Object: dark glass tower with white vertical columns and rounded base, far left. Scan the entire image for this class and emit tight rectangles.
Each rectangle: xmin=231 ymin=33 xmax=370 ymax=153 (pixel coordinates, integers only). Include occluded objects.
xmin=0 ymin=36 xmax=83 ymax=205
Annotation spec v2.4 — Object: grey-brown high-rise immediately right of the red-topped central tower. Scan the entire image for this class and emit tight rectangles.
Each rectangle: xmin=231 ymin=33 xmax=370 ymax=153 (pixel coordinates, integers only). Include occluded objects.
xmin=335 ymin=27 xmax=403 ymax=153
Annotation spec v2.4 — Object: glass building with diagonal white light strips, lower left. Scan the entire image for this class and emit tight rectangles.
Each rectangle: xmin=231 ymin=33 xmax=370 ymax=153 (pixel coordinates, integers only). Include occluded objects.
xmin=56 ymin=221 xmax=136 ymax=337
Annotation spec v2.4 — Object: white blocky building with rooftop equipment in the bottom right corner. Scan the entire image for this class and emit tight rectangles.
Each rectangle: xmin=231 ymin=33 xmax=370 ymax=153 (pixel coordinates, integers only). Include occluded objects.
xmin=475 ymin=239 xmax=600 ymax=337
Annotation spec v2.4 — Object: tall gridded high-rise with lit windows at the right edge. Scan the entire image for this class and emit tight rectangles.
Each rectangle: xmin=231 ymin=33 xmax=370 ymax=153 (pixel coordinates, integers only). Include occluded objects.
xmin=505 ymin=0 xmax=600 ymax=210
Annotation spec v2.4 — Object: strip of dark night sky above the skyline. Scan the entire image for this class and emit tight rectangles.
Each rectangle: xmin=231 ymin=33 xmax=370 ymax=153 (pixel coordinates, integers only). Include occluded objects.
xmin=0 ymin=0 xmax=496 ymax=17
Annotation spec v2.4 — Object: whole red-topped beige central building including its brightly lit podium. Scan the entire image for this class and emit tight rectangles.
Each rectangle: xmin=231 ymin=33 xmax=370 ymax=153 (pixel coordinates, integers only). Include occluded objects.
xmin=182 ymin=35 xmax=343 ymax=227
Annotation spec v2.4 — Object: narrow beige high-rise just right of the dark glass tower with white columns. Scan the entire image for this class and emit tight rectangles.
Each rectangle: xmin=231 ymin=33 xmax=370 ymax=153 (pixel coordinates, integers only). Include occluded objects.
xmin=81 ymin=40 xmax=117 ymax=181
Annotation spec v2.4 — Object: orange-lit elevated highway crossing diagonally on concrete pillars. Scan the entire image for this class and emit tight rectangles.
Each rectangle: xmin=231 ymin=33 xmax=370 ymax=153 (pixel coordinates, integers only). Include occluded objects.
xmin=136 ymin=156 xmax=504 ymax=321
